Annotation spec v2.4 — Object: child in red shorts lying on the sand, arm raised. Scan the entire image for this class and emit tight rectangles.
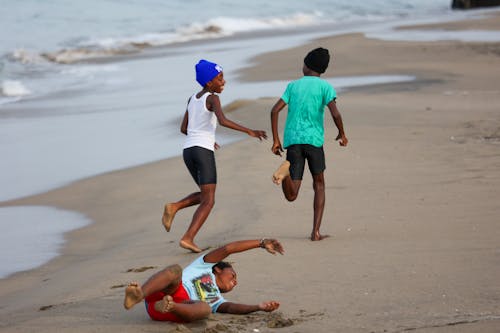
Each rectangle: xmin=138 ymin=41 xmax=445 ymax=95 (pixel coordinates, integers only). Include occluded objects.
xmin=123 ymin=238 xmax=284 ymax=322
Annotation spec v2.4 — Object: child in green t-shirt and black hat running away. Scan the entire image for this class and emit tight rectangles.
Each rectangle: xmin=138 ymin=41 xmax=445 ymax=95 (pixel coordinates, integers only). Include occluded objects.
xmin=271 ymin=48 xmax=348 ymax=241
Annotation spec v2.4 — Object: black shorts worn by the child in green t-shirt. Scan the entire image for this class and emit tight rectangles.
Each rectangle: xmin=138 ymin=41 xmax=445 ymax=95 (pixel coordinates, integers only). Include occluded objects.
xmin=286 ymin=144 xmax=326 ymax=180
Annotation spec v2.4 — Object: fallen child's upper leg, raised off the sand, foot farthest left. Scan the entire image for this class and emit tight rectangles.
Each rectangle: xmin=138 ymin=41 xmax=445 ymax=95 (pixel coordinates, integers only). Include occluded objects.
xmin=123 ymin=264 xmax=182 ymax=310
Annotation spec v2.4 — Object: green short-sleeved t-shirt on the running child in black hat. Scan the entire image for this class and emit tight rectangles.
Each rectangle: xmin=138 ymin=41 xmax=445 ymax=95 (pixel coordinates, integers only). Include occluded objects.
xmin=281 ymin=76 xmax=337 ymax=148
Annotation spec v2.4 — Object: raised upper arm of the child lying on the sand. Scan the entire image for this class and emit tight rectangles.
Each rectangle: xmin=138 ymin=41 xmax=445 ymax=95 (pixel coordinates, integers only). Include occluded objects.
xmin=203 ymin=238 xmax=284 ymax=263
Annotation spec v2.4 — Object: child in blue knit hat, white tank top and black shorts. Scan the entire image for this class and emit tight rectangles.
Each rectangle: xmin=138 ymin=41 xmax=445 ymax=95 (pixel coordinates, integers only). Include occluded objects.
xmin=162 ymin=59 xmax=267 ymax=253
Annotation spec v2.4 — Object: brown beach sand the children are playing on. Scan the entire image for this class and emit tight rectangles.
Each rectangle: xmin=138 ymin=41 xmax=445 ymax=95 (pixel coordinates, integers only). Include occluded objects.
xmin=0 ymin=11 xmax=500 ymax=333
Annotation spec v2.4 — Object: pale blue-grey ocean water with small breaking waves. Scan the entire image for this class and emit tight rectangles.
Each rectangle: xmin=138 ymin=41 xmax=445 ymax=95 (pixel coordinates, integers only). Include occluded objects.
xmin=0 ymin=0 xmax=498 ymax=277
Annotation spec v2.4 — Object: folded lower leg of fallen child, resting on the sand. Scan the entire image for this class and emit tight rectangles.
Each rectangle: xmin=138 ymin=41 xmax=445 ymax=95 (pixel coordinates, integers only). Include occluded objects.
xmin=155 ymin=295 xmax=212 ymax=322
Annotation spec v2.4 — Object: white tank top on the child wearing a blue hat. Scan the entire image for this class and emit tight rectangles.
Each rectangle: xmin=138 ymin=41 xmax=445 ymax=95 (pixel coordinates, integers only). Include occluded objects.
xmin=184 ymin=92 xmax=217 ymax=151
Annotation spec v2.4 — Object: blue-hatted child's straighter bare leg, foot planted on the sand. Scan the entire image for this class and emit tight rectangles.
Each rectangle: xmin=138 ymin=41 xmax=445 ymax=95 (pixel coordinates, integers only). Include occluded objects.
xmin=179 ymin=184 xmax=216 ymax=253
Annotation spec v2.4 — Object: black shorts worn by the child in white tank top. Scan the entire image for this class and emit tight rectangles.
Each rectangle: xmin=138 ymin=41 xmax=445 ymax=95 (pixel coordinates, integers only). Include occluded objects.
xmin=182 ymin=146 xmax=217 ymax=186
